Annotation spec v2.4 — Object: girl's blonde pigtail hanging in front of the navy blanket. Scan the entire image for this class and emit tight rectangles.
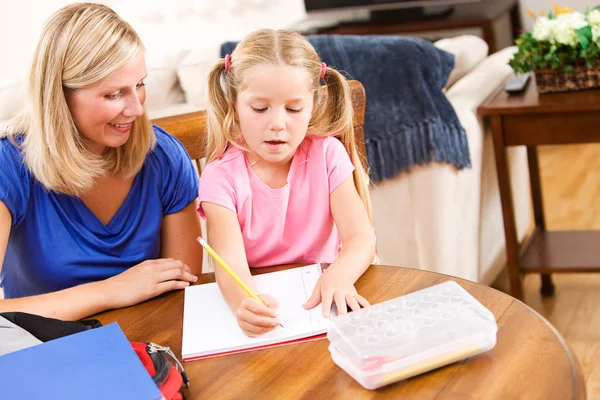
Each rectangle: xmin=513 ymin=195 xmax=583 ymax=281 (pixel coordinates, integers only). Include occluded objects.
xmin=315 ymin=67 xmax=374 ymax=226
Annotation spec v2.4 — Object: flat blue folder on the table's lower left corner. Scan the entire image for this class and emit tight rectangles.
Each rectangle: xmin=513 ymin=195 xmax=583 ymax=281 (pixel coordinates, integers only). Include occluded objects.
xmin=0 ymin=323 xmax=162 ymax=400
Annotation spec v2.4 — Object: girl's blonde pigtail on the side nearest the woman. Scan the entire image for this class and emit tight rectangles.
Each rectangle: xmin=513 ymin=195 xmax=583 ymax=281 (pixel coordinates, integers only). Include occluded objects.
xmin=206 ymin=59 xmax=234 ymax=163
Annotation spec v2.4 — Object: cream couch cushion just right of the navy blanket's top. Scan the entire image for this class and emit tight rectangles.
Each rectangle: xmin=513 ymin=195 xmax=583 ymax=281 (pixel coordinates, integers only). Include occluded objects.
xmin=434 ymin=35 xmax=488 ymax=88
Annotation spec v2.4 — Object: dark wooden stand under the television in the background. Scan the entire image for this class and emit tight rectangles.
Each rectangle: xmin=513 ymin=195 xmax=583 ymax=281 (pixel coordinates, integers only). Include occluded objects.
xmin=318 ymin=0 xmax=521 ymax=54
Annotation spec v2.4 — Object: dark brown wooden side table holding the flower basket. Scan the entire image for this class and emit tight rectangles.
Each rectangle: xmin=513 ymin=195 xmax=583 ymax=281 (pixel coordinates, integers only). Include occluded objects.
xmin=477 ymin=79 xmax=600 ymax=299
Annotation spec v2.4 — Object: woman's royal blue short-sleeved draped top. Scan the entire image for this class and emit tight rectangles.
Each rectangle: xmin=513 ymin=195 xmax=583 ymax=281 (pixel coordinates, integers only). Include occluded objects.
xmin=0 ymin=126 xmax=198 ymax=298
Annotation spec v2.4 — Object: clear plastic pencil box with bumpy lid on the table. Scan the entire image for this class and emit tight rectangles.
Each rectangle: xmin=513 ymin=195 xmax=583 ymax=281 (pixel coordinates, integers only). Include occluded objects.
xmin=327 ymin=281 xmax=498 ymax=389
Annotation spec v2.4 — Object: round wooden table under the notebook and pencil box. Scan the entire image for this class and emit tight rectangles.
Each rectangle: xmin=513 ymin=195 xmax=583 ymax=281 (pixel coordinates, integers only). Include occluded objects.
xmin=95 ymin=266 xmax=586 ymax=400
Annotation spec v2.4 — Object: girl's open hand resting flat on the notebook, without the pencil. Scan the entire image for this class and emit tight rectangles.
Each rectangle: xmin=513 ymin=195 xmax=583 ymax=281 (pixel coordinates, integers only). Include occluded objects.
xmin=304 ymin=268 xmax=370 ymax=318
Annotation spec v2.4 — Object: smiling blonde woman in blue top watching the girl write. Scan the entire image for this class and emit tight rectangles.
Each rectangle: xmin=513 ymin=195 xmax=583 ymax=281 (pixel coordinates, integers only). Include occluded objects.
xmin=0 ymin=3 xmax=202 ymax=320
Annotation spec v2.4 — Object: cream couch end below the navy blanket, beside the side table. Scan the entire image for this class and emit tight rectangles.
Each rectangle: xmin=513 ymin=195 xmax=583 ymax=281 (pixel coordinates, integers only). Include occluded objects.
xmin=372 ymin=37 xmax=531 ymax=284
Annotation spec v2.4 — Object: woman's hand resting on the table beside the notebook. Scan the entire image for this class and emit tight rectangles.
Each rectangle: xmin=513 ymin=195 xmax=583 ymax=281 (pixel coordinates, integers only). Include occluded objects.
xmin=102 ymin=258 xmax=198 ymax=308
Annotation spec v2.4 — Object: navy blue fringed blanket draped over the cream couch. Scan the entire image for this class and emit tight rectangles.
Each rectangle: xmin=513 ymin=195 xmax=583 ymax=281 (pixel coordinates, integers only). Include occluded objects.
xmin=221 ymin=35 xmax=471 ymax=181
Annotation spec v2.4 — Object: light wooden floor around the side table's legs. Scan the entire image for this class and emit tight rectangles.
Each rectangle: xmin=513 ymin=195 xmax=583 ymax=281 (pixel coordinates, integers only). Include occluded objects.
xmin=494 ymin=144 xmax=600 ymax=400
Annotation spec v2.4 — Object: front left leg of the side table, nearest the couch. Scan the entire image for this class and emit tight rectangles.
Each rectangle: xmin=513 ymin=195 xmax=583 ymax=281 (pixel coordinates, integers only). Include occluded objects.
xmin=490 ymin=116 xmax=523 ymax=300
